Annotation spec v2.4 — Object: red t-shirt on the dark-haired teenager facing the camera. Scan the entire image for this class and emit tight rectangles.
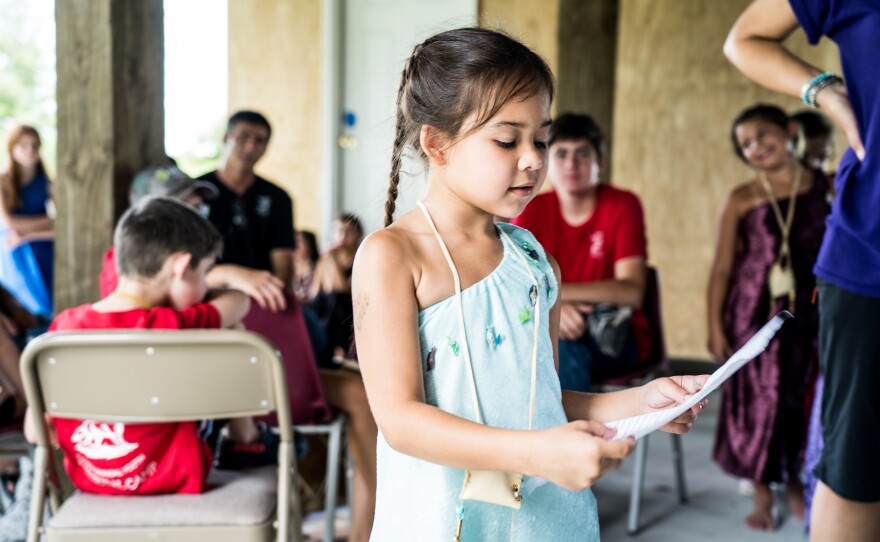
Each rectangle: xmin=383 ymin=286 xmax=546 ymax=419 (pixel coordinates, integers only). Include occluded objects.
xmin=511 ymin=184 xmax=651 ymax=360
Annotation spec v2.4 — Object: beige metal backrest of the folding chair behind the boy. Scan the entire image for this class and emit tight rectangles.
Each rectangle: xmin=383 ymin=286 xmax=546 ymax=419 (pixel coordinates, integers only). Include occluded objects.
xmin=21 ymin=330 xmax=290 ymax=434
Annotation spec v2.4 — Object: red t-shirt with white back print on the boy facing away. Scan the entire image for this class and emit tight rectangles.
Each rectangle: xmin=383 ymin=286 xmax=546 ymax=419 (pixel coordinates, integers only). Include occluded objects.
xmin=49 ymin=303 xmax=220 ymax=495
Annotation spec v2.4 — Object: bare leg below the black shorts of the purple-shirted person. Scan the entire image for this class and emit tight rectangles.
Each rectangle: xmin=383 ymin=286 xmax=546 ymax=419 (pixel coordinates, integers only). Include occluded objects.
xmin=810 ymin=481 xmax=880 ymax=542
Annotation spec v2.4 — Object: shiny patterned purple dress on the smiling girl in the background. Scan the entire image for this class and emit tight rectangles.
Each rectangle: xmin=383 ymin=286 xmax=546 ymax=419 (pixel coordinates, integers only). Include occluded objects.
xmin=713 ymin=172 xmax=829 ymax=483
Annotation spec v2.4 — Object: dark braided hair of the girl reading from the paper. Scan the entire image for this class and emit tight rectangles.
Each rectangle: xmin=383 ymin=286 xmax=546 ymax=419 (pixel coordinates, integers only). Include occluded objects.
xmin=385 ymin=28 xmax=554 ymax=226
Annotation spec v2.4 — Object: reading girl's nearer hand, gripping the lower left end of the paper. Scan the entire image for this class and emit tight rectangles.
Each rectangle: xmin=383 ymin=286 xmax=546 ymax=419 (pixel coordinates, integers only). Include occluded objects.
xmin=532 ymin=420 xmax=636 ymax=491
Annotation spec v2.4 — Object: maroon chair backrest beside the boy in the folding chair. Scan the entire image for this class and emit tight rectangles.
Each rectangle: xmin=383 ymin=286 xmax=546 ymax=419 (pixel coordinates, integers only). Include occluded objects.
xmin=244 ymin=293 xmax=331 ymax=425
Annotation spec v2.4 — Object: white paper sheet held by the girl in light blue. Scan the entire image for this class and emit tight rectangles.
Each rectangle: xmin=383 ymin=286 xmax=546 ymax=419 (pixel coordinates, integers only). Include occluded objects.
xmin=605 ymin=311 xmax=794 ymax=440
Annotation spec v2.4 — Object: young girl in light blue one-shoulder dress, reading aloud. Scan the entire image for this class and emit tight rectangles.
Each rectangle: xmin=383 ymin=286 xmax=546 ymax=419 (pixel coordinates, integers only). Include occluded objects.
xmin=352 ymin=28 xmax=705 ymax=542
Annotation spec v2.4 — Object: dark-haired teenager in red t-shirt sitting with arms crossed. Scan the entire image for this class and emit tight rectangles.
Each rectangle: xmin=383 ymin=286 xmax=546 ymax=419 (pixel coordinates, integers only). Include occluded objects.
xmin=511 ymin=113 xmax=651 ymax=391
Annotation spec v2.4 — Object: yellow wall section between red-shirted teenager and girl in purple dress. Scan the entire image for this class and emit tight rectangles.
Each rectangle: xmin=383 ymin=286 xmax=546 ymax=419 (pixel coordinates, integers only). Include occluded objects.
xmin=612 ymin=0 xmax=842 ymax=358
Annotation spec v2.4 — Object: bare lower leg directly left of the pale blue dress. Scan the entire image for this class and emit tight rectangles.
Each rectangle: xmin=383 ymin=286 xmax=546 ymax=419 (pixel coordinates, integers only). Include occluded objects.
xmin=321 ymin=370 xmax=378 ymax=542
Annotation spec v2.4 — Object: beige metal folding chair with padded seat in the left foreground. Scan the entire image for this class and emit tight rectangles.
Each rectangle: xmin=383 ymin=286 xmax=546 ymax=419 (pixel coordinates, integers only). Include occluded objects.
xmin=21 ymin=330 xmax=302 ymax=542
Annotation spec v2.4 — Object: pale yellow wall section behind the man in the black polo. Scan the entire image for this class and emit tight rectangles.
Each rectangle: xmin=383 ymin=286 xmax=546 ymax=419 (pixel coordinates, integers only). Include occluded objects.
xmin=229 ymin=0 xmax=321 ymax=231
